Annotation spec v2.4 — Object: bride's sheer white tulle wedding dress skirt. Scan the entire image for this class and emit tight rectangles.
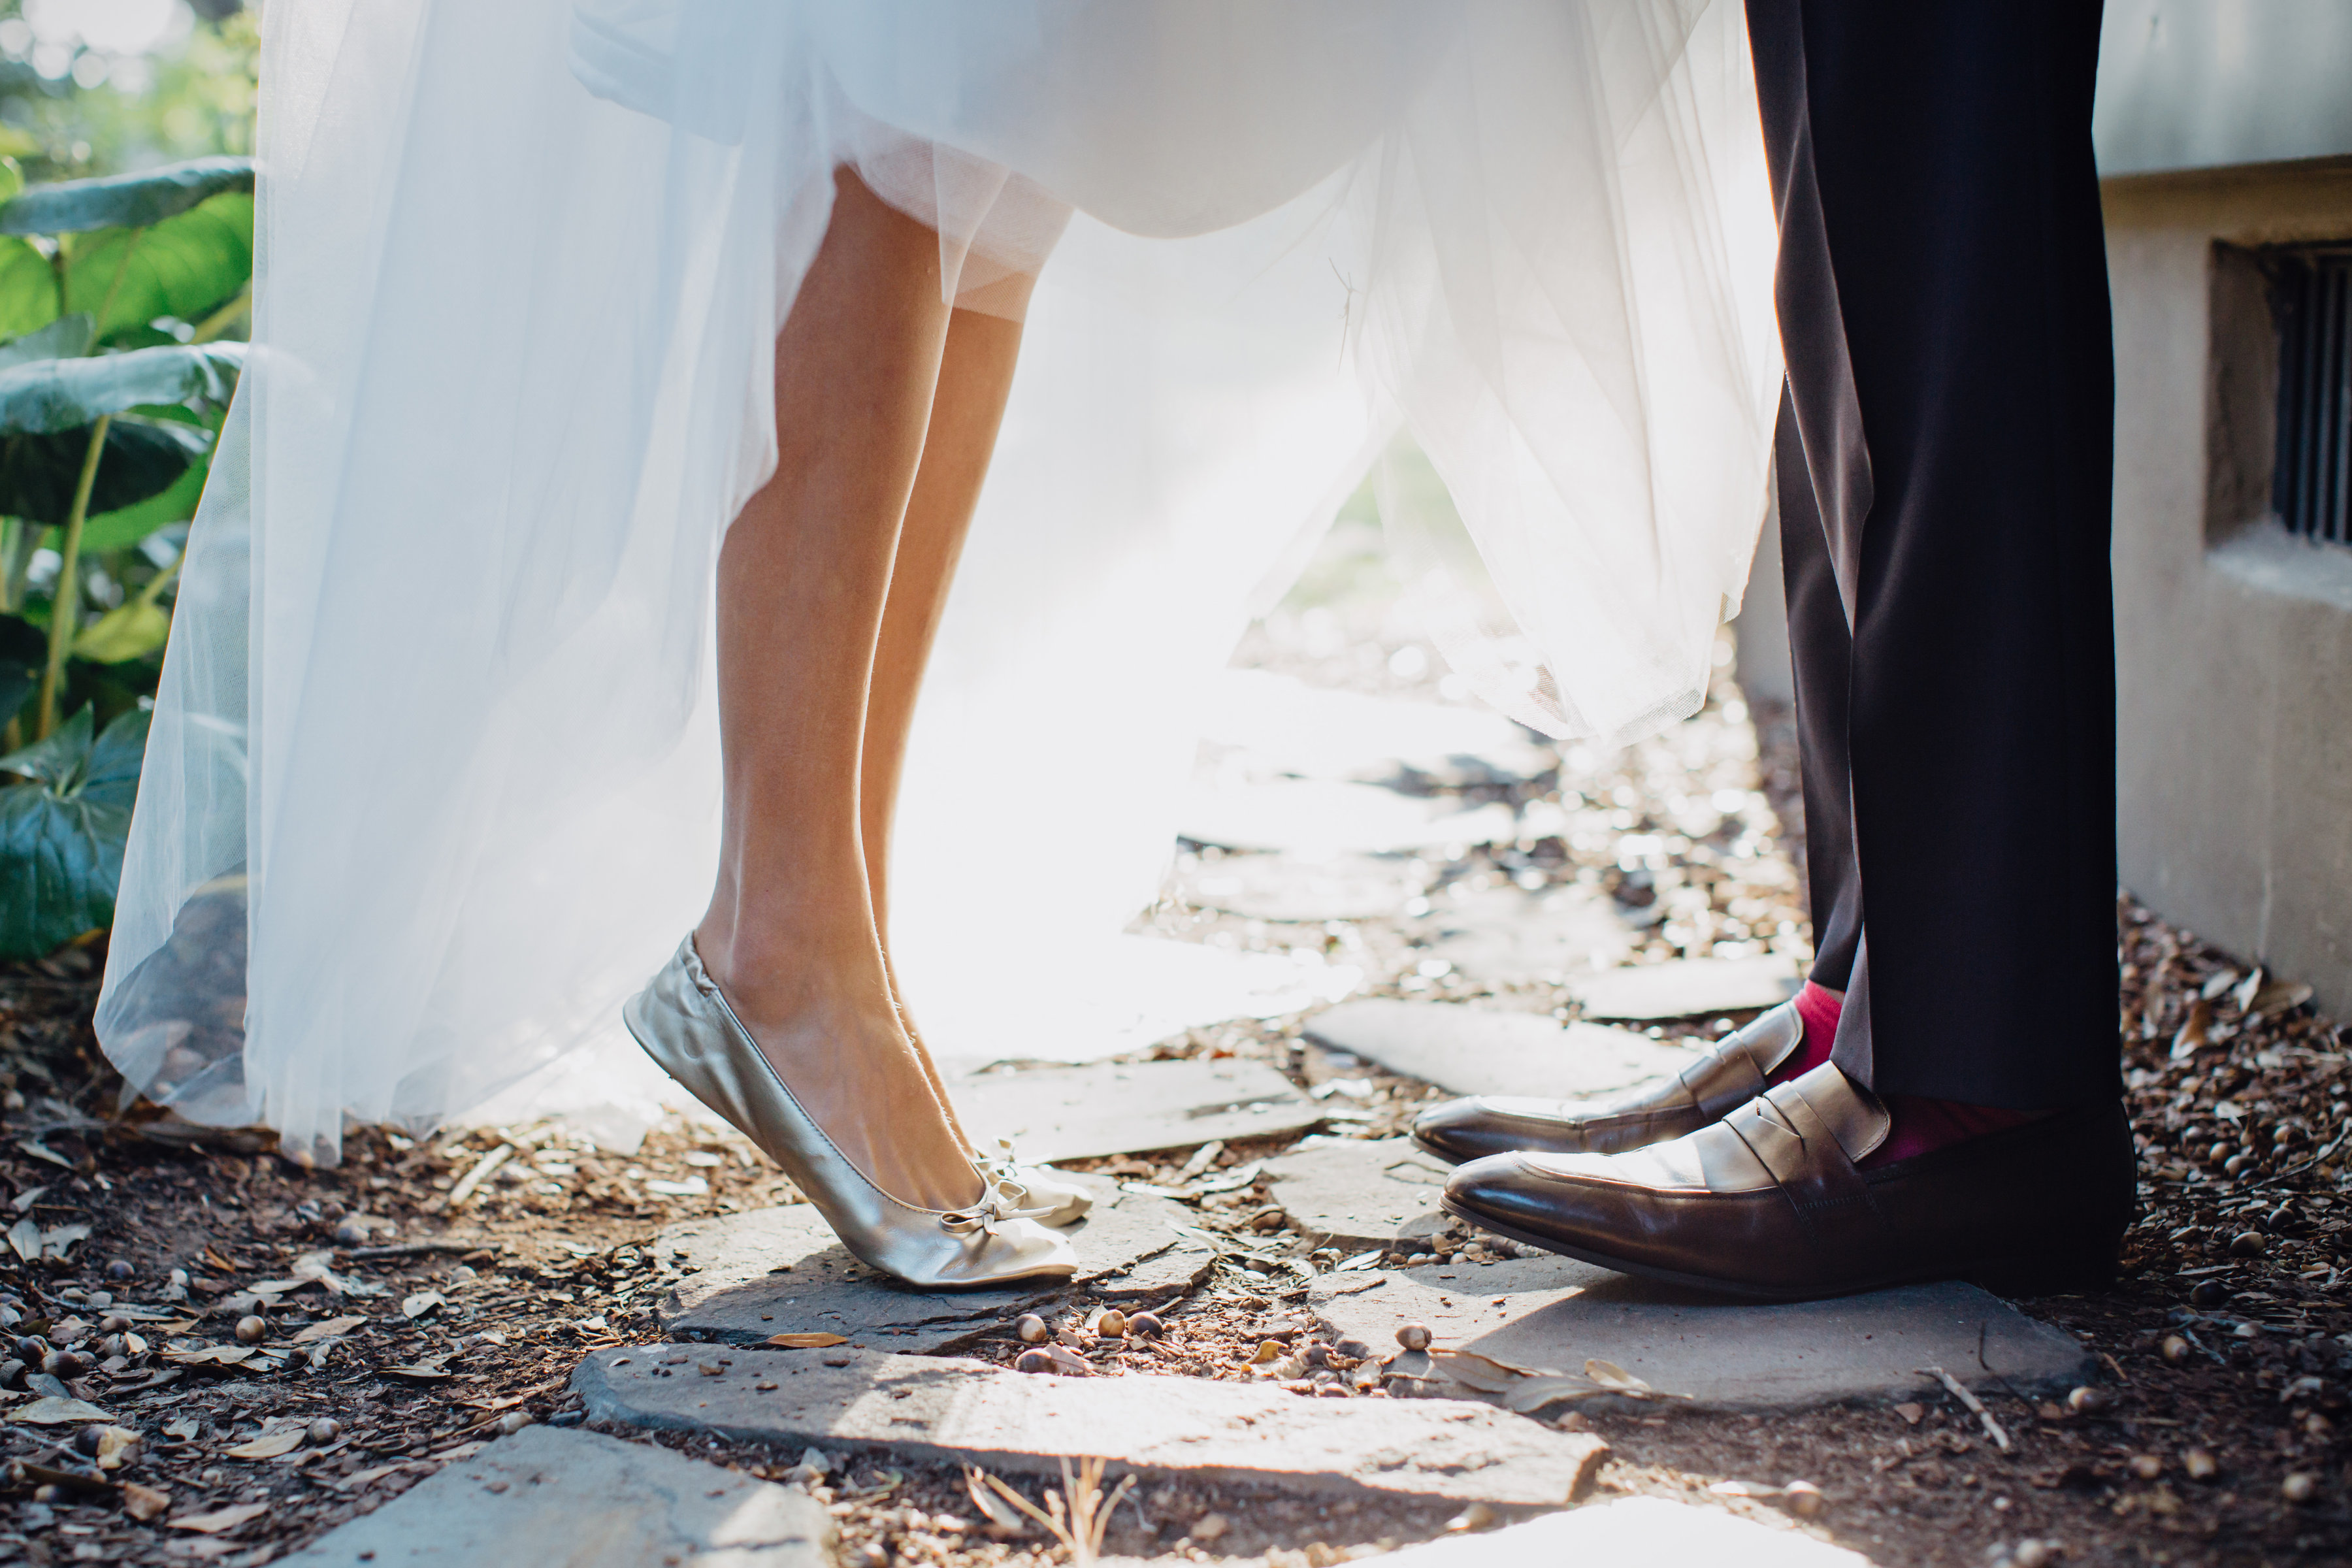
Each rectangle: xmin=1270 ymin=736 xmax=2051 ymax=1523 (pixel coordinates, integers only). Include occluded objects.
xmin=99 ymin=0 xmax=1780 ymax=1162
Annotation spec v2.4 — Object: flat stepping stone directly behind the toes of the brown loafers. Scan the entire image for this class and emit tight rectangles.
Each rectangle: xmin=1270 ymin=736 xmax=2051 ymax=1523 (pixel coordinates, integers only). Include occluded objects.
xmin=1305 ymin=997 xmax=1696 ymax=1100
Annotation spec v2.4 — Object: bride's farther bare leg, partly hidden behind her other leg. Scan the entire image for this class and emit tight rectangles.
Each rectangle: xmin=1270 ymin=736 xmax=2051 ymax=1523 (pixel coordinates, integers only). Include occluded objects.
xmin=858 ymin=278 xmax=1028 ymax=1133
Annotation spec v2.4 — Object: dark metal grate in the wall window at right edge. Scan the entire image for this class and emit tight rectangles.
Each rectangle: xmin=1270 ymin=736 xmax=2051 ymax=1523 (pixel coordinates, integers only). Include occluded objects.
xmin=2270 ymin=247 xmax=2352 ymax=546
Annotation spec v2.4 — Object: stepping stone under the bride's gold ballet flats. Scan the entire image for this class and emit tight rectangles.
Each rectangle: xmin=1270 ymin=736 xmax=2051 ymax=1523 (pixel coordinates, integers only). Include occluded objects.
xmin=654 ymin=1175 xmax=1216 ymax=1354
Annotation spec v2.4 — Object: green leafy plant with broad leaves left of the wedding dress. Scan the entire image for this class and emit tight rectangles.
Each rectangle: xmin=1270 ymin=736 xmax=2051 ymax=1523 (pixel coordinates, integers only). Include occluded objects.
xmin=0 ymin=157 xmax=254 ymax=959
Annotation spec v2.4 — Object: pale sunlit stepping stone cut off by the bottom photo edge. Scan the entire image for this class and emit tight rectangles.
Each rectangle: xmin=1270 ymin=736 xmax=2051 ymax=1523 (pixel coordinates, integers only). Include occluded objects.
xmin=1380 ymin=1497 xmax=1870 ymax=1568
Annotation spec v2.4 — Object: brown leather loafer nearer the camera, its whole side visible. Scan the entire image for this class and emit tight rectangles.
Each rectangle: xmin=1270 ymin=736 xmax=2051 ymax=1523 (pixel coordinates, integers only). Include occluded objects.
xmin=1444 ymin=1062 xmax=2136 ymax=1300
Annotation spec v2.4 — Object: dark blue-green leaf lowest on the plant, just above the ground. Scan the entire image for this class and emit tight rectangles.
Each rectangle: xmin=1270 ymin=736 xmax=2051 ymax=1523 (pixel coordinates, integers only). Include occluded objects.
xmin=0 ymin=708 xmax=148 ymax=959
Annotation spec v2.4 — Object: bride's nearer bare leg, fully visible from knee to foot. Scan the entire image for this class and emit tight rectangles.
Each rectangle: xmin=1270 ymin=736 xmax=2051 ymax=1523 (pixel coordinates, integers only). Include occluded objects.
xmin=694 ymin=172 xmax=981 ymax=1208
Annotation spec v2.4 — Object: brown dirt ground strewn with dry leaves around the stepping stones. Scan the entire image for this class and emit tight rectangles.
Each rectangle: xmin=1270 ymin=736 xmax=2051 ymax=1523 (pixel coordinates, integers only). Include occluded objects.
xmin=0 ymin=595 xmax=2352 ymax=1568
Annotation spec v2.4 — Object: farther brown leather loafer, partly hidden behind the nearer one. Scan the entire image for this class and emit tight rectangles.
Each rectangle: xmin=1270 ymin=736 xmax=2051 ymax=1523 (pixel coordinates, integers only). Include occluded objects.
xmin=1414 ymin=1002 xmax=1804 ymax=1166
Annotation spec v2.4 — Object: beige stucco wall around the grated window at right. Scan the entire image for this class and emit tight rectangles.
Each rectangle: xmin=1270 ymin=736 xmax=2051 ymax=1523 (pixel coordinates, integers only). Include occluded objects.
xmin=2105 ymin=160 xmax=2352 ymax=1015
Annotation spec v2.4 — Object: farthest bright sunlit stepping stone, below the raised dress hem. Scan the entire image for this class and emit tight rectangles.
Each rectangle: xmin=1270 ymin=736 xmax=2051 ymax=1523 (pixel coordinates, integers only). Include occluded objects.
xmin=1202 ymin=670 xmax=1560 ymax=787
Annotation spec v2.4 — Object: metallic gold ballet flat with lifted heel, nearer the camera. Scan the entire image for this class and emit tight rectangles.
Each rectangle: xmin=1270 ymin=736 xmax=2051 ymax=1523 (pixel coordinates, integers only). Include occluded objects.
xmin=621 ymin=933 xmax=1077 ymax=1290
